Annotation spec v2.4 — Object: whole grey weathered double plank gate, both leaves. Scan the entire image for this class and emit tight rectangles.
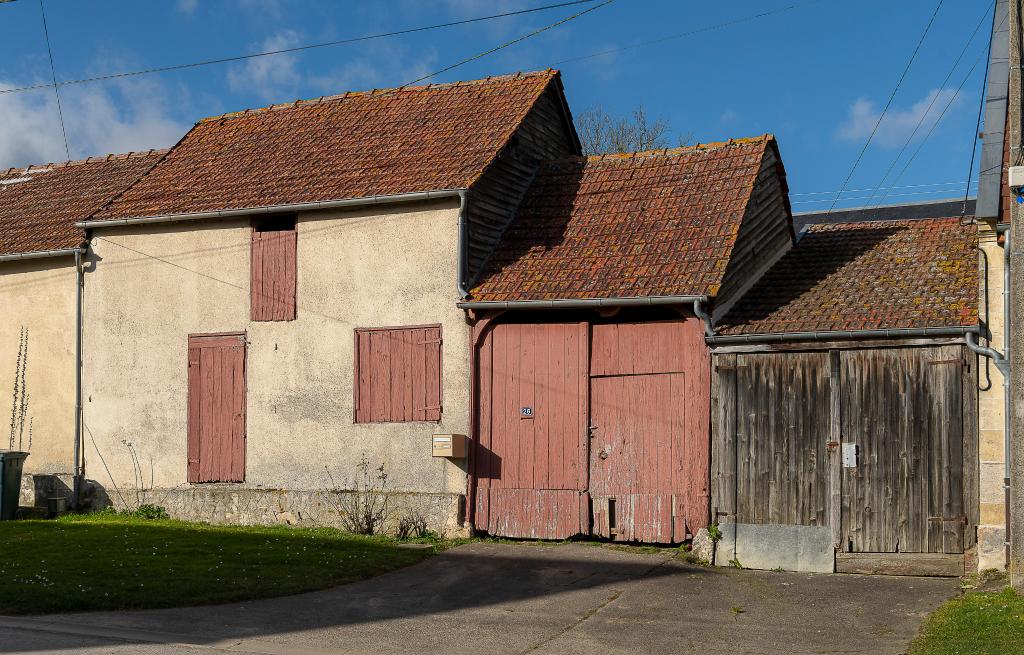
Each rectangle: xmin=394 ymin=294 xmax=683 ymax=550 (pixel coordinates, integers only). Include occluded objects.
xmin=712 ymin=345 xmax=977 ymax=554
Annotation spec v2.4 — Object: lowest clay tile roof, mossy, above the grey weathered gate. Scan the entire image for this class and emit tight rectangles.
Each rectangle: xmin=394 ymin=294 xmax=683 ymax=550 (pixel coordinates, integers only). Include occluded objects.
xmin=718 ymin=217 xmax=978 ymax=335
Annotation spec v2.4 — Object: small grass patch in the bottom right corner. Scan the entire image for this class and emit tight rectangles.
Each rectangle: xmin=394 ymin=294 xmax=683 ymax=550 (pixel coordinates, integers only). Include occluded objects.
xmin=910 ymin=590 xmax=1024 ymax=655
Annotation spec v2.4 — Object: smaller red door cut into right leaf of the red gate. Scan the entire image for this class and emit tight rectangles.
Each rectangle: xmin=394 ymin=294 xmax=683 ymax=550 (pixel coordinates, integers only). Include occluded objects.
xmin=590 ymin=373 xmax=692 ymax=543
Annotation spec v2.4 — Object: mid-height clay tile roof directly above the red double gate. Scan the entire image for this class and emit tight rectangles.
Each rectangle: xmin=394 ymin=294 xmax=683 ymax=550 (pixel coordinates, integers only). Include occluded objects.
xmin=471 ymin=135 xmax=774 ymax=301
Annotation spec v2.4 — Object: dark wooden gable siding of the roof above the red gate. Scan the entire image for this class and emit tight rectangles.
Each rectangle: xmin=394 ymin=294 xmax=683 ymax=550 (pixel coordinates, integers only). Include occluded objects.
xmin=715 ymin=143 xmax=794 ymax=307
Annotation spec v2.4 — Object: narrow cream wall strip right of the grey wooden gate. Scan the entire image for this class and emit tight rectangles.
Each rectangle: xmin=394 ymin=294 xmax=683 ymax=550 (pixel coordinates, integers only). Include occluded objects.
xmin=978 ymin=222 xmax=1006 ymax=570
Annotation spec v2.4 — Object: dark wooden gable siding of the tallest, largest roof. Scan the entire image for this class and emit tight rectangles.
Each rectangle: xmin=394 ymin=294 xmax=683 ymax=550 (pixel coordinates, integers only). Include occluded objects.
xmin=467 ymin=86 xmax=579 ymax=279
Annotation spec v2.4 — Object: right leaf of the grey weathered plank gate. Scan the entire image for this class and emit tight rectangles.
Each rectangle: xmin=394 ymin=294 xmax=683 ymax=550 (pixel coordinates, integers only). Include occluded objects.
xmin=839 ymin=346 xmax=967 ymax=554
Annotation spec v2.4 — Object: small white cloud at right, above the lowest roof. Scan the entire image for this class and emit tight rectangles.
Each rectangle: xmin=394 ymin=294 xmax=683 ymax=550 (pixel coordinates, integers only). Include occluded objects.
xmin=837 ymin=89 xmax=961 ymax=147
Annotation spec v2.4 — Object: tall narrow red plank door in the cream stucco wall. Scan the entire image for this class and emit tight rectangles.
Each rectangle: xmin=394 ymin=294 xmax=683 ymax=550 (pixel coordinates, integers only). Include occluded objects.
xmin=188 ymin=334 xmax=246 ymax=482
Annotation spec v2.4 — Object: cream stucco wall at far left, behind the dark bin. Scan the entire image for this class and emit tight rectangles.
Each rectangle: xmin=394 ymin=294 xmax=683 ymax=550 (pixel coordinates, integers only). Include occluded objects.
xmin=0 ymin=257 xmax=76 ymax=473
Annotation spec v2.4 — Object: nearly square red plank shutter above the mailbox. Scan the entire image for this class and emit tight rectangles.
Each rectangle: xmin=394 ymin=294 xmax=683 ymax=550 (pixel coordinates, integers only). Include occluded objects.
xmin=354 ymin=325 xmax=441 ymax=423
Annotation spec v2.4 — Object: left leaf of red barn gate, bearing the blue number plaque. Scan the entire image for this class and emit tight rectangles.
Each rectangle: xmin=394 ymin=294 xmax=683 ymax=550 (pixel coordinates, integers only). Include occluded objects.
xmin=474 ymin=322 xmax=589 ymax=539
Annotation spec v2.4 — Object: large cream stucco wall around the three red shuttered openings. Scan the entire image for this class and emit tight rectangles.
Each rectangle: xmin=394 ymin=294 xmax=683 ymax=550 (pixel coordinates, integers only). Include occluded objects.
xmin=84 ymin=202 xmax=469 ymax=528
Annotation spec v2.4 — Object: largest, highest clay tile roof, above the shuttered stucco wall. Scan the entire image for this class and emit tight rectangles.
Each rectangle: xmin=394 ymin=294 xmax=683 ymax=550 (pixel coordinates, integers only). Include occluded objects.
xmin=94 ymin=71 xmax=558 ymax=220
